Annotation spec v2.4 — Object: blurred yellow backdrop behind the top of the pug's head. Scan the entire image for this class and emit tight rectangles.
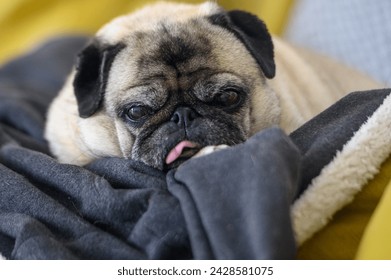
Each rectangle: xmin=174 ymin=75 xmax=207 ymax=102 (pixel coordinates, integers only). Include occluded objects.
xmin=0 ymin=0 xmax=293 ymax=63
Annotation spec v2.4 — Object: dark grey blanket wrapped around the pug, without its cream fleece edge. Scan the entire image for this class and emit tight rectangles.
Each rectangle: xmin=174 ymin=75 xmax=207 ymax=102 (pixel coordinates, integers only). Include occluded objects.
xmin=0 ymin=37 xmax=389 ymax=259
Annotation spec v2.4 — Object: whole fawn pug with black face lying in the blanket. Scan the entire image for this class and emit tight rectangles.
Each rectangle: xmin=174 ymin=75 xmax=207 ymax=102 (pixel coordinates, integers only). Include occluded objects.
xmin=45 ymin=2 xmax=379 ymax=170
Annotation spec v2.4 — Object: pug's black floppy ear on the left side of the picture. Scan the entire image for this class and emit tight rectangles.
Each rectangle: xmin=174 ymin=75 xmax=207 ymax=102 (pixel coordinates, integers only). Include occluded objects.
xmin=73 ymin=41 xmax=124 ymax=118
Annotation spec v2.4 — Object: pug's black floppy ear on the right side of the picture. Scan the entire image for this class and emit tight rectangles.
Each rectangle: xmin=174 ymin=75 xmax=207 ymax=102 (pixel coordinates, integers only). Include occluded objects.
xmin=210 ymin=10 xmax=276 ymax=79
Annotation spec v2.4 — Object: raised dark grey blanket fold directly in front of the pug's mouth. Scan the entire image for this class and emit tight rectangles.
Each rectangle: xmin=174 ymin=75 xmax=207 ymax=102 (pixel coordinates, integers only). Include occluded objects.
xmin=168 ymin=128 xmax=300 ymax=259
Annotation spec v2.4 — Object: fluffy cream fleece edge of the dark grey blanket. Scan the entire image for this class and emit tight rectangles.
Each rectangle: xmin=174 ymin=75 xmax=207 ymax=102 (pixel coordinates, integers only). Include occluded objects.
xmin=291 ymin=92 xmax=391 ymax=246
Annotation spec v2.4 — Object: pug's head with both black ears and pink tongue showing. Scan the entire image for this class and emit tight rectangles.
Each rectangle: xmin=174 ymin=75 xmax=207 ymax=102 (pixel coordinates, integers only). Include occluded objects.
xmin=69 ymin=3 xmax=278 ymax=170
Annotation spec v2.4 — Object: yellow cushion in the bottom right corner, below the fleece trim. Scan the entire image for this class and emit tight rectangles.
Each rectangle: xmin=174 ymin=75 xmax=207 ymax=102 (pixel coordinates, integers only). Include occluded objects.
xmin=298 ymin=154 xmax=391 ymax=259
